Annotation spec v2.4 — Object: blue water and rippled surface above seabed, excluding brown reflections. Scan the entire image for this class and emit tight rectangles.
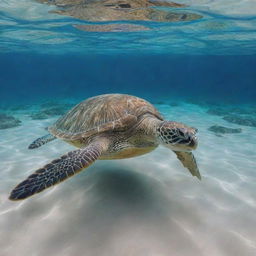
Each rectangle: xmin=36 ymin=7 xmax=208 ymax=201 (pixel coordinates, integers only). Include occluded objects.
xmin=0 ymin=0 xmax=256 ymax=104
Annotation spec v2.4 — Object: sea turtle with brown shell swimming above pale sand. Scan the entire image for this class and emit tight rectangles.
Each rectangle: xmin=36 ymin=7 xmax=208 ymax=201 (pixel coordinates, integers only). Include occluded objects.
xmin=10 ymin=94 xmax=201 ymax=200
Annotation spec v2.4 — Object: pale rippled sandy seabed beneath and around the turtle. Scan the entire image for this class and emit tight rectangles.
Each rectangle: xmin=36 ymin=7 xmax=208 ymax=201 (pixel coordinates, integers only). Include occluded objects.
xmin=0 ymin=104 xmax=256 ymax=256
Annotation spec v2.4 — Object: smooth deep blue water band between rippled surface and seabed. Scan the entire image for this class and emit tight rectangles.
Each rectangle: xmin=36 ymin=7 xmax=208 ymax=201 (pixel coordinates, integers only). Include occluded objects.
xmin=0 ymin=53 xmax=256 ymax=104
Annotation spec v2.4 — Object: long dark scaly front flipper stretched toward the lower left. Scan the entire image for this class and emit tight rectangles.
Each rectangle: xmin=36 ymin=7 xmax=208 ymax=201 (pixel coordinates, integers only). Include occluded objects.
xmin=9 ymin=141 xmax=106 ymax=200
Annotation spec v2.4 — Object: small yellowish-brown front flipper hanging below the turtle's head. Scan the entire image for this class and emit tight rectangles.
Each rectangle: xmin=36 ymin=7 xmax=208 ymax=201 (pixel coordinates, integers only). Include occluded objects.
xmin=173 ymin=151 xmax=201 ymax=180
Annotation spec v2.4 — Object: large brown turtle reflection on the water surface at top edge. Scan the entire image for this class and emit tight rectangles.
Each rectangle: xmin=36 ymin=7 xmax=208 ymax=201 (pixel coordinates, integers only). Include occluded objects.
xmin=38 ymin=0 xmax=202 ymax=29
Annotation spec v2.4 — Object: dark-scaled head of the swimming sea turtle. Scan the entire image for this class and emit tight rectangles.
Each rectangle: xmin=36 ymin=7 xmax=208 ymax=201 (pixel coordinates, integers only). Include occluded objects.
xmin=157 ymin=121 xmax=197 ymax=151
